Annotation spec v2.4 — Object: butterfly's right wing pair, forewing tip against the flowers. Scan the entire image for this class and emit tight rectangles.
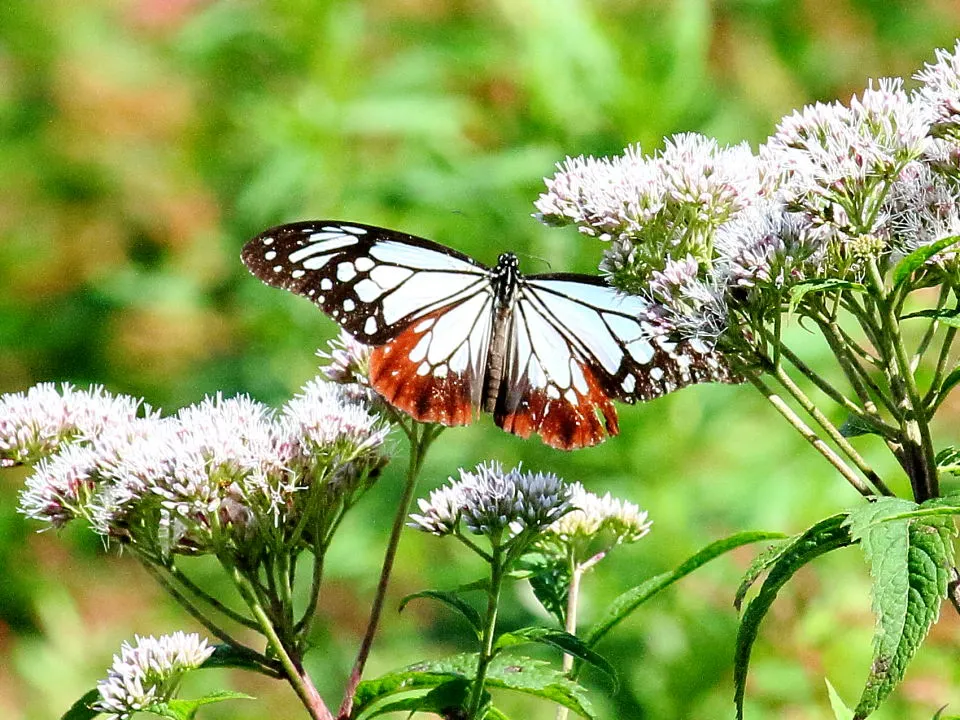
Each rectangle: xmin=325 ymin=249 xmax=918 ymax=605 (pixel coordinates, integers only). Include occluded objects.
xmin=494 ymin=273 xmax=732 ymax=449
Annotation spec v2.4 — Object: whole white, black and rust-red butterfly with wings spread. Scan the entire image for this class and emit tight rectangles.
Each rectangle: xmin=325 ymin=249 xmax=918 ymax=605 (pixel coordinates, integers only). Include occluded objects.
xmin=242 ymin=220 xmax=734 ymax=450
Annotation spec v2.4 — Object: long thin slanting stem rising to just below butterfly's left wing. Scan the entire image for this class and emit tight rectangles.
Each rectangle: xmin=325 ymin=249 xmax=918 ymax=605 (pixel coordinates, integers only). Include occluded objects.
xmin=337 ymin=423 xmax=443 ymax=720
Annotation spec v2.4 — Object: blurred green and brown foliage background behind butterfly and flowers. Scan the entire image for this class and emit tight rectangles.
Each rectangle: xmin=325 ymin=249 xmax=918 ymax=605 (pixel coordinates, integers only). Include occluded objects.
xmin=0 ymin=0 xmax=960 ymax=720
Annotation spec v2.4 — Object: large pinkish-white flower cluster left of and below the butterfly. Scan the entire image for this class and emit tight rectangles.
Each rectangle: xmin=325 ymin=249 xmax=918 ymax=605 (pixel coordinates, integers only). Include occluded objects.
xmin=9 ymin=380 xmax=389 ymax=553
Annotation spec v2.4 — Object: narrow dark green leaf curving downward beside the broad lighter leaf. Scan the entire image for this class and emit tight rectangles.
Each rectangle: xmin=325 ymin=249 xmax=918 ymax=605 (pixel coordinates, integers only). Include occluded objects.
xmin=733 ymin=513 xmax=853 ymax=720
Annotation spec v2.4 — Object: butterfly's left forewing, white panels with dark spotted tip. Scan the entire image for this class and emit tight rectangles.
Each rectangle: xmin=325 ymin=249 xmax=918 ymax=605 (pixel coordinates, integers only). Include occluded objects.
xmin=242 ymin=221 xmax=490 ymax=345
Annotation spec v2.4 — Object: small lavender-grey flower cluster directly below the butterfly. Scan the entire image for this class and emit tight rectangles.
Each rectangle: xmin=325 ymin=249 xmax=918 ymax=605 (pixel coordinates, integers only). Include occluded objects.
xmin=410 ymin=462 xmax=570 ymax=540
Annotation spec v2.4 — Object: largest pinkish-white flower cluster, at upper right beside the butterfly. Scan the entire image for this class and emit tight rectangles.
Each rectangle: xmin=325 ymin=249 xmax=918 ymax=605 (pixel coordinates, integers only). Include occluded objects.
xmin=536 ymin=42 xmax=960 ymax=343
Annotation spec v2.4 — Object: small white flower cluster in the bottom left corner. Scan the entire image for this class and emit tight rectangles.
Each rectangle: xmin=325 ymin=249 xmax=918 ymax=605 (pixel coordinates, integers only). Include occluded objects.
xmin=93 ymin=632 xmax=214 ymax=720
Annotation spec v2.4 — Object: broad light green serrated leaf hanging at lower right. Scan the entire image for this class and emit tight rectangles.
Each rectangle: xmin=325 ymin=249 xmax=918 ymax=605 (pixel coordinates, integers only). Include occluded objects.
xmin=848 ymin=498 xmax=956 ymax=720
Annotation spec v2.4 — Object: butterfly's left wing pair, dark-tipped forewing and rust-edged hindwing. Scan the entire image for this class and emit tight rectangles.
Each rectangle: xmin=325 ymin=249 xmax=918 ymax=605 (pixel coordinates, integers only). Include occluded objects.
xmin=242 ymin=220 xmax=493 ymax=425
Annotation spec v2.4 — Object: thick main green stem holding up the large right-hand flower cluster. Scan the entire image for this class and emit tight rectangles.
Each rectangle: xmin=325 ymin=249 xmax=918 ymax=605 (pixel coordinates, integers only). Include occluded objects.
xmin=867 ymin=258 xmax=940 ymax=503
